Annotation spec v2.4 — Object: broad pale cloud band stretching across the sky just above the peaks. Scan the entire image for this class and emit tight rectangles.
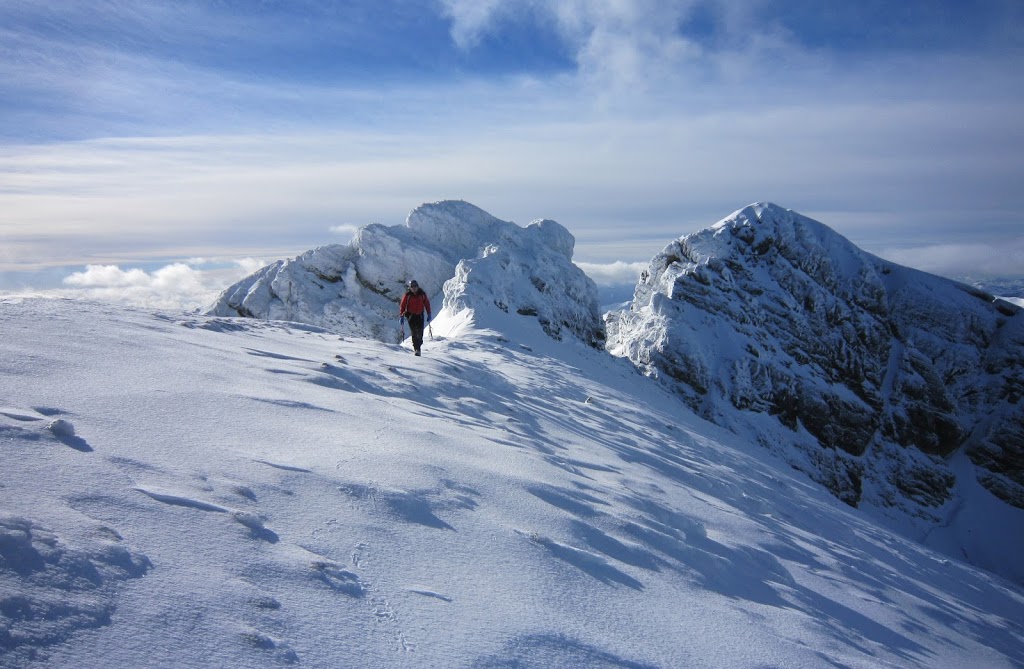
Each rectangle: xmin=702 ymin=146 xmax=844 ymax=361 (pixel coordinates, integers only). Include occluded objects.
xmin=0 ymin=86 xmax=1024 ymax=271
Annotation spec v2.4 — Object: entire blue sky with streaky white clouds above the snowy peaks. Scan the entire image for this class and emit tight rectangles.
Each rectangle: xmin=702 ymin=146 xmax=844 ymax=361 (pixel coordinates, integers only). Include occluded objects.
xmin=0 ymin=0 xmax=1024 ymax=303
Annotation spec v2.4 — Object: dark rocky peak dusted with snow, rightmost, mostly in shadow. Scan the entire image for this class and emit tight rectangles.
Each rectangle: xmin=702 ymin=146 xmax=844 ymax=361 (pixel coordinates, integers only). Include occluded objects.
xmin=608 ymin=205 xmax=1024 ymax=573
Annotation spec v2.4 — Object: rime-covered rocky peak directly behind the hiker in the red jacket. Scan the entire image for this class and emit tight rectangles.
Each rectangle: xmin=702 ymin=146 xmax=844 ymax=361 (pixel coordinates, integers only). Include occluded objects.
xmin=209 ymin=201 xmax=603 ymax=342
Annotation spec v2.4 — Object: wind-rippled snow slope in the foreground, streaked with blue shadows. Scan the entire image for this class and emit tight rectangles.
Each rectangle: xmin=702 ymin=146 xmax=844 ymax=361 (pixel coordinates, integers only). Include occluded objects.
xmin=6 ymin=299 xmax=1024 ymax=668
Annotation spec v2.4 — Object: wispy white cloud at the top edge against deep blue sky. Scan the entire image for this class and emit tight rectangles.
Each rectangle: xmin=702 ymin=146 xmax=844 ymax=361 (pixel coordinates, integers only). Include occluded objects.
xmin=441 ymin=0 xmax=822 ymax=99
